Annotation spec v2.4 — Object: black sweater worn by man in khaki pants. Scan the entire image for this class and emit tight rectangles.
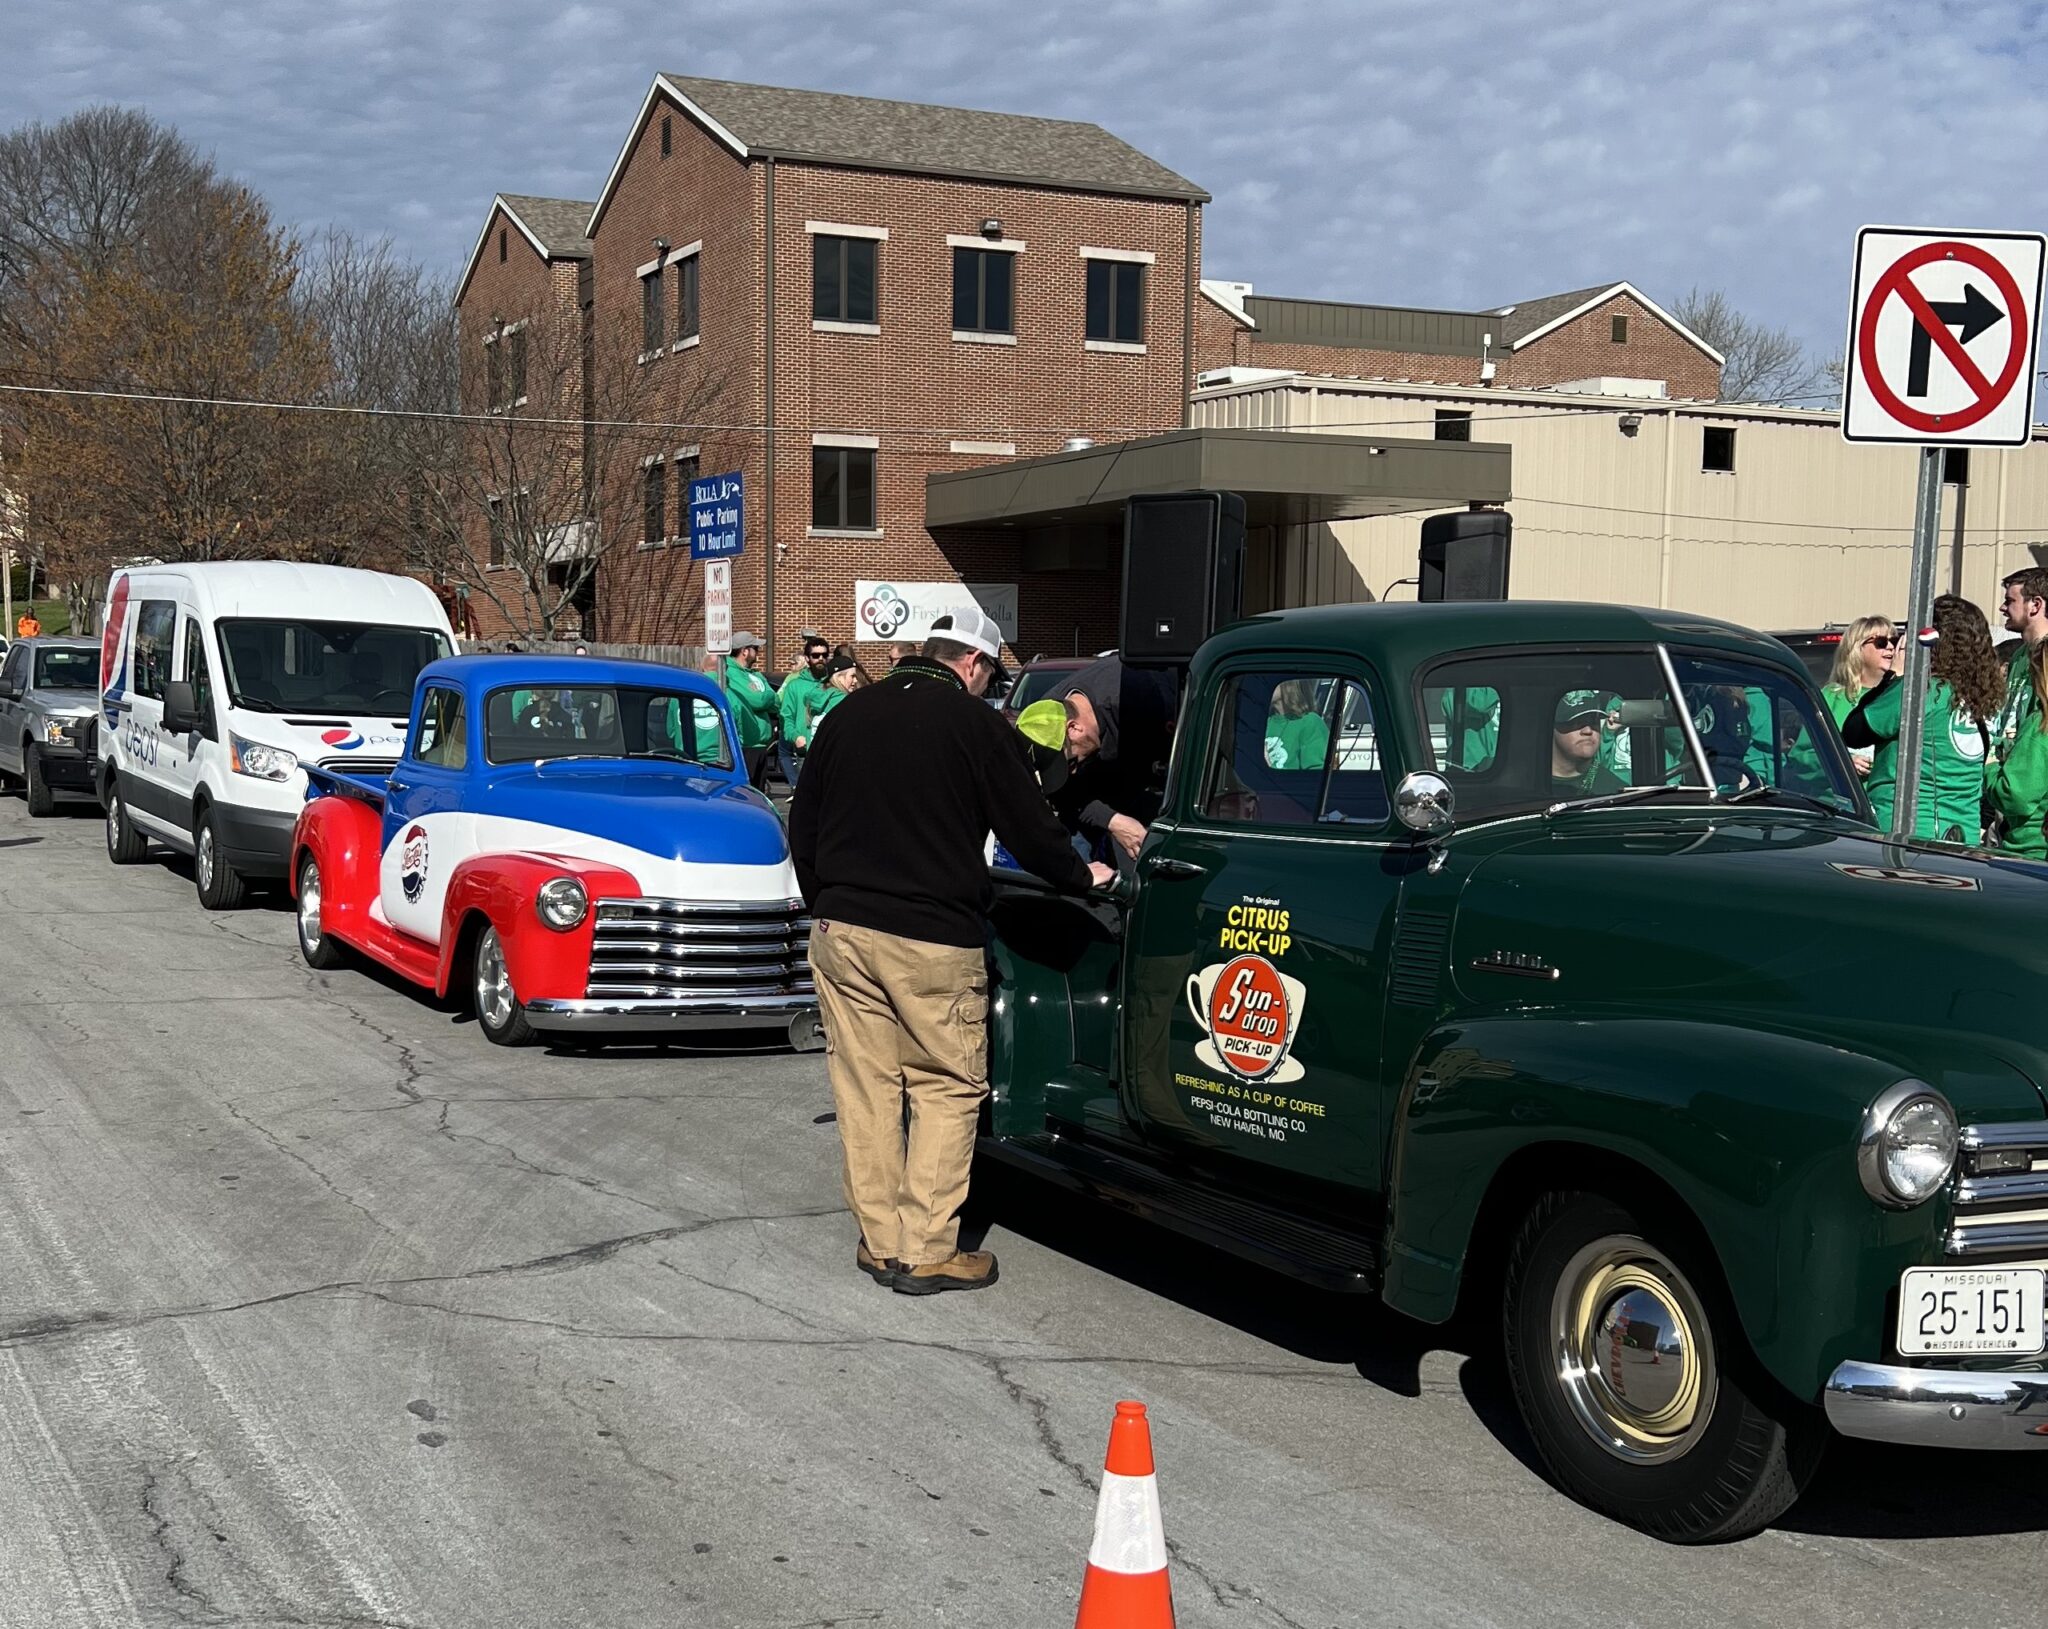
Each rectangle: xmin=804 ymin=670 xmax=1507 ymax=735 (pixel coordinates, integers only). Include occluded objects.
xmin=788 ymin=656 xmax=1087 ymax=947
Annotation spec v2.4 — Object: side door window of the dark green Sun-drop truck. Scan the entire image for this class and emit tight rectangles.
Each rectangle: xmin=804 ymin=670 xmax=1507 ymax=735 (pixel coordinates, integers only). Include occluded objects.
xmin=1202 ymin=672 xmax=1386 ymax=826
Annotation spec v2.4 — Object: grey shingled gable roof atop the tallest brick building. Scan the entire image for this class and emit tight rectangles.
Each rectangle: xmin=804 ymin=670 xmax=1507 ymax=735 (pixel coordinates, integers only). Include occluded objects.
xmin=586 ymin=74 xmax=1208 ymax=234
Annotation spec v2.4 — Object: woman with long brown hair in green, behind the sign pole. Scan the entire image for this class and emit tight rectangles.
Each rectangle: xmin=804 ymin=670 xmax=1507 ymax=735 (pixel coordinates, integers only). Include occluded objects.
xmin=1841 ymin=594 xmax=2005 ymax=842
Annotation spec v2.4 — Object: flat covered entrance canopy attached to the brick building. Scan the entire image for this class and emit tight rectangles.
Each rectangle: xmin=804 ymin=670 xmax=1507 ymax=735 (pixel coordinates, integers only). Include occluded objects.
xmin=924 ymin=428 xmax=1509 ymax=594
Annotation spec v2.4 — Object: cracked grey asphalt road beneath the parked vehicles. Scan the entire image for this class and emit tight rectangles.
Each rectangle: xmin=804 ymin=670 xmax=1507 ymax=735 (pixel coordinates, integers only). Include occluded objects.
xmin=0 ymin=799 xmax=2048 ymax=1629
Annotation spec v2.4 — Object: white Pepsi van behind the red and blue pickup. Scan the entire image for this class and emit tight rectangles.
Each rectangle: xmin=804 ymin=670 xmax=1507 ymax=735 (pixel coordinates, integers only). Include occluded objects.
xmin=94 ymin=559 xmax=455 ymax=910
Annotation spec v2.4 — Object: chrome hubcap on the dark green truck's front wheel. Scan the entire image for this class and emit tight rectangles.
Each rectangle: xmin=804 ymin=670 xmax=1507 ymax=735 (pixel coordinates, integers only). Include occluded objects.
xmin=1550 ymin=1236 xmax=1716 ymax=1465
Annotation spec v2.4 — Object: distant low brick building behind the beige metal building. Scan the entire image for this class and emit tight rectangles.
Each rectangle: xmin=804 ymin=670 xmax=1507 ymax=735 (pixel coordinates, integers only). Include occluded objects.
xmin=1196 ymin=281 xmax=1720 ymax=400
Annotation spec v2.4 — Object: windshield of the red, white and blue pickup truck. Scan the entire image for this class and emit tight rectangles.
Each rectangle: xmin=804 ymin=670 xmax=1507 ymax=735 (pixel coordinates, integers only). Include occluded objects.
xmin=483 ymin=684 xmax=733 ymax=768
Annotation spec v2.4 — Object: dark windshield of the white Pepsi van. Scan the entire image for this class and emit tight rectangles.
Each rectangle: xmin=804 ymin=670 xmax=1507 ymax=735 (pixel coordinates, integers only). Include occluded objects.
xmin=219 ymin=617 xmax=451 ymax=719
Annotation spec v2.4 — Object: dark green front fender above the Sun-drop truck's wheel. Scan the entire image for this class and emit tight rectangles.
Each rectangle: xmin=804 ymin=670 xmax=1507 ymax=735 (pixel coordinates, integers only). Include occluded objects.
xmin=1386 ymin=1012 xmax=1950 ymax=1400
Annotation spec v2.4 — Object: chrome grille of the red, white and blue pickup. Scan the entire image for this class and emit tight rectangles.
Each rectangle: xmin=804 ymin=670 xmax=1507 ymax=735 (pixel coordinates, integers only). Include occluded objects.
xmin=590 ymin=900 xmax=811 ymax=1000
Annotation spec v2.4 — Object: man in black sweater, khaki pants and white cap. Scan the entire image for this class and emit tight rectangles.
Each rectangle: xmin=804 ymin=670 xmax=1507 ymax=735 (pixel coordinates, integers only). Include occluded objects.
xmin=788 ymin=611 xmax=1112 ymax=1295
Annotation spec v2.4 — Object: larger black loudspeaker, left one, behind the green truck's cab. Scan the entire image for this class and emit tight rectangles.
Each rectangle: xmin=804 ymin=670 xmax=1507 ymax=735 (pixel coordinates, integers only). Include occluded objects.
xmin=1120 ymin=492 xmax=1245 ymax=666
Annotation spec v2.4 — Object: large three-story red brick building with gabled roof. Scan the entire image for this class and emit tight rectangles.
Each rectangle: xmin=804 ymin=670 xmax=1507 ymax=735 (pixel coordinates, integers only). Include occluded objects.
xmin=459 ymin=74 xmax=1208 ymax=666
